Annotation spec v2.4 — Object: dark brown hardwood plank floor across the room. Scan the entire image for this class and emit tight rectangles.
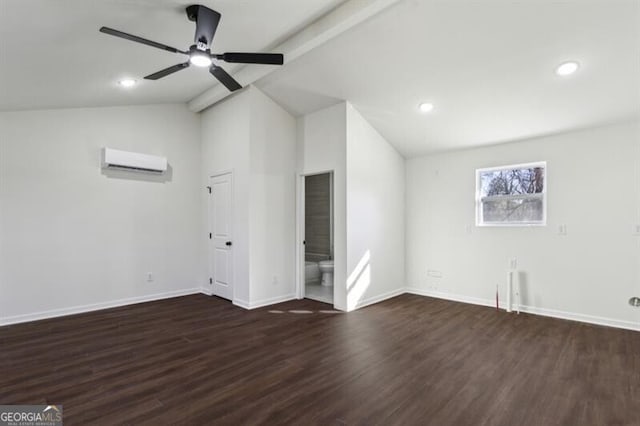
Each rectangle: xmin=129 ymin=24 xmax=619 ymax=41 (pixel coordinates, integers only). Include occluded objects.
xmin=0 ymin=295 xmax=640 ymax=426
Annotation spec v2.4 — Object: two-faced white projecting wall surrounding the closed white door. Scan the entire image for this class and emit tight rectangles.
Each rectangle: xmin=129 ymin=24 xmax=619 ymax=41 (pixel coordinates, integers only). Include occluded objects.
xmin=200 ymin=86 xmax=296 ymax=308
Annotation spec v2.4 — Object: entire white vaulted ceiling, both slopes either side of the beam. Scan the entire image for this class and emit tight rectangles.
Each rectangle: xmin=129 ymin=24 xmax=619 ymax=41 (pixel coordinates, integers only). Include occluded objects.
xmin=0 ymin=0 xmax=640 ymax=156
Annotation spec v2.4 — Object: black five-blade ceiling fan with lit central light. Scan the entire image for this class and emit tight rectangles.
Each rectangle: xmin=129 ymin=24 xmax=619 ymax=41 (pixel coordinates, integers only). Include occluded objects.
xmin=100 ymin=5 xmax=284 ymax=92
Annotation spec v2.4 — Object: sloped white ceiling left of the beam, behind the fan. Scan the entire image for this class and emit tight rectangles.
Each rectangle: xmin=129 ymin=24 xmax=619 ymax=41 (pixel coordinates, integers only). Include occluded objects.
xmin=0 ymin=0 xmax=344 ymax=110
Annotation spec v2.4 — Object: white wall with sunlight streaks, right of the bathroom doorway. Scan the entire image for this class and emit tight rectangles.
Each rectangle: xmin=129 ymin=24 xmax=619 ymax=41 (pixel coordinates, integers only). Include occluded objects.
xmin=346 ymin=104 xmax=405 ymax=310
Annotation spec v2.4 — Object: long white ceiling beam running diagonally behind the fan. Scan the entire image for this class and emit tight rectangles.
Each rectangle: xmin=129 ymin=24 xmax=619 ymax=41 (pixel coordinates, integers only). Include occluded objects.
xmin=188 ymin=0 xmax=400 ymax=112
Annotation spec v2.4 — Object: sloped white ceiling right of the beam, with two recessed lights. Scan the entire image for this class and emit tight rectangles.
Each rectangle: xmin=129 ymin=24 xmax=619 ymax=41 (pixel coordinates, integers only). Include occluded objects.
xmin=258 ymin=0 xmax=640 ymax=156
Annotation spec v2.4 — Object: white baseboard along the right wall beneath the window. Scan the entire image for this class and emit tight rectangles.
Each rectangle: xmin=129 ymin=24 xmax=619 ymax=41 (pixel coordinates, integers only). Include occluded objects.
xmin=406 ymin=287 xmax=640 ymax=331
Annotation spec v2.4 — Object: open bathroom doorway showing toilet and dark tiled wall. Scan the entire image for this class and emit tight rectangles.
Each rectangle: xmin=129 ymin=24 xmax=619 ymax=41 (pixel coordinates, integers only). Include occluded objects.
xmin=302 ymin=172 xmax=334 ymax=305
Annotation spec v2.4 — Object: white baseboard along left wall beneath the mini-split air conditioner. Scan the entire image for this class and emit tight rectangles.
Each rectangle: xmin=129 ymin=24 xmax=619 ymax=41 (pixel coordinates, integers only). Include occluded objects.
xmin=0 ymin=288 xmax=202 ymax=326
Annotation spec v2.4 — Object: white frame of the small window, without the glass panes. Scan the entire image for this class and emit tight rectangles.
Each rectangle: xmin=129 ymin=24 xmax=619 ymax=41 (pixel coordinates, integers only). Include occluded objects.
xmin=476 ymin=161 xmax=549 ymax=228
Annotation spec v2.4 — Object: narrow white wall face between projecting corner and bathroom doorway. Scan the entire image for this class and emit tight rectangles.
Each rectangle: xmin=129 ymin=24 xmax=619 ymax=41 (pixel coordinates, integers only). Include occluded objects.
xmin=249 ymin=86 xmax=296 ymax=305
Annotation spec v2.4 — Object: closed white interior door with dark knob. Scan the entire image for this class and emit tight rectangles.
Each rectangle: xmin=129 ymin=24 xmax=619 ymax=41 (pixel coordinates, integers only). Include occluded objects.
xmin=209 ymin=173 xmax=233 ymax=300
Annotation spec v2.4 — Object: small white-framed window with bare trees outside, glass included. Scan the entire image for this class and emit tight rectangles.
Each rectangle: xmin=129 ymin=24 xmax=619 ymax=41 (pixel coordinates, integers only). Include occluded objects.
xmin=476 ymin=162 xmax=547 ymax=226
